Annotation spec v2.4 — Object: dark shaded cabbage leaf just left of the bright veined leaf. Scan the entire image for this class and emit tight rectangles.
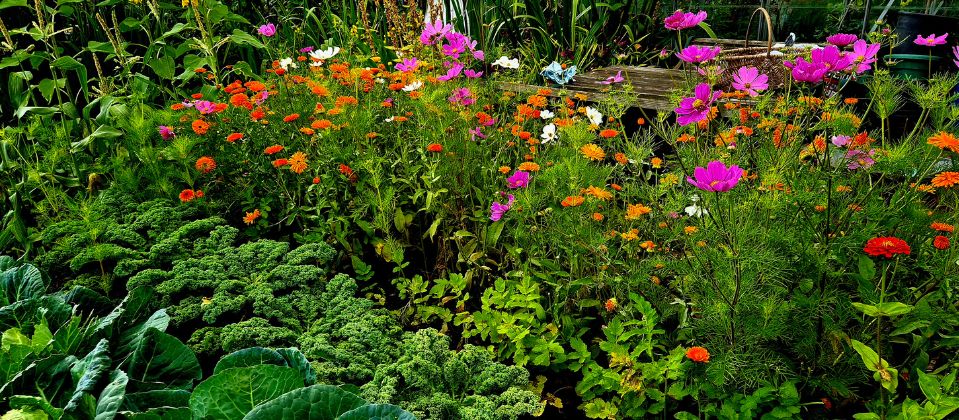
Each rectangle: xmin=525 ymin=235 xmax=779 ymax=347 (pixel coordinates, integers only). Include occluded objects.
xmin=126 ymin=328 xmax=203 ymax=391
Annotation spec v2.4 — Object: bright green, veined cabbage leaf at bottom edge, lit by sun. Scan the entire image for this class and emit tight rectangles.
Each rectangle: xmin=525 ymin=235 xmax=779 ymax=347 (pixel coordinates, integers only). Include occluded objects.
xmin=190 ymin=365 xmax=303 ymax=420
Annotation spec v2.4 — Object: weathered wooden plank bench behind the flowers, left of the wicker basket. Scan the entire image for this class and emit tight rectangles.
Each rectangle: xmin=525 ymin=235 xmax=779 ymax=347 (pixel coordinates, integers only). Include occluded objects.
xmin=499 ymin=66 xmax=683 ymax=111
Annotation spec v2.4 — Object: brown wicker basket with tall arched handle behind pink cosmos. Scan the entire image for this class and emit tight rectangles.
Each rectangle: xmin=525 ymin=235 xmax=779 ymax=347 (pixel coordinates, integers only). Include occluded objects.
xmin=719 ymin=7 xmax=789 ymax=92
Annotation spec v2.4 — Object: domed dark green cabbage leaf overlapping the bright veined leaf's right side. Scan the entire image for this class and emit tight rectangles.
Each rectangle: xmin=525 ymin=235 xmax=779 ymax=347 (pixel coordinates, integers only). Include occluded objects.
xmin=243 ymin=385 xmax=366 ymax=420
